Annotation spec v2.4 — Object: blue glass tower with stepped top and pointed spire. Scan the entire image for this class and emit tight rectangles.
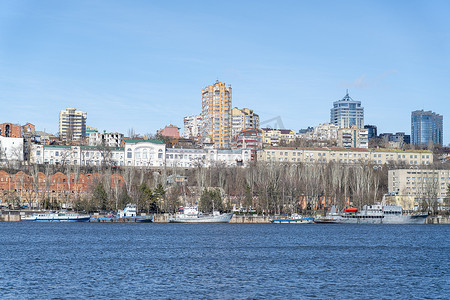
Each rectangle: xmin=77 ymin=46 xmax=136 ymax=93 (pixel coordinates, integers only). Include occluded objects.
xmin=330 ymin=91 xmax=364 ymax=128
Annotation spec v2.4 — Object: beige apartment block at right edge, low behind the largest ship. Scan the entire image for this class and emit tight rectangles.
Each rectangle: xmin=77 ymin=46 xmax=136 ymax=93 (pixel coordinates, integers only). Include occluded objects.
xmin=386 ymin=169 xmax=450 ymax=210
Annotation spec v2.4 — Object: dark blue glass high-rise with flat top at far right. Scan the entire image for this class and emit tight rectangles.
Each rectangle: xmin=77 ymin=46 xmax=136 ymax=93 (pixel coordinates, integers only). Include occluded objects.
xmin=411 ymin=110 xmax=444 ymax=146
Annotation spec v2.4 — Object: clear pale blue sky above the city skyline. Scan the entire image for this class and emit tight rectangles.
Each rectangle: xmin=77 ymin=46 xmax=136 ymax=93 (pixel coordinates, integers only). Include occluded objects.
xmin=0 ymin=0 xmax=450 ymax=144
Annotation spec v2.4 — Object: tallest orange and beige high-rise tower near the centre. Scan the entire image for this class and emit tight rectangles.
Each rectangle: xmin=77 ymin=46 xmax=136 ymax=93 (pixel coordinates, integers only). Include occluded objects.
xmin=201 ymin=80 xmax=232 ymax=149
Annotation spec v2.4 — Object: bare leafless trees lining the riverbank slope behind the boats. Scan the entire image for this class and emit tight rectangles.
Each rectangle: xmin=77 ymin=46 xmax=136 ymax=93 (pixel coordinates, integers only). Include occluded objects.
xmin=1 ymin=162 xmax=450 ymax=214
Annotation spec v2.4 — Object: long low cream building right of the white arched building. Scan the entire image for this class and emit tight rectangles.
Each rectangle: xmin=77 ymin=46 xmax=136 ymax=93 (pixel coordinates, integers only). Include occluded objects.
xmin=257 ymin=147 xmax=433 ymax=166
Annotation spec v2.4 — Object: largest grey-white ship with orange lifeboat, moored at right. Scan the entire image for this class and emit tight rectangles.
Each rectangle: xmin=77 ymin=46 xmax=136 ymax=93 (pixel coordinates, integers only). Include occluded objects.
xmin=314 ymin=204 xmax=428 ymax=224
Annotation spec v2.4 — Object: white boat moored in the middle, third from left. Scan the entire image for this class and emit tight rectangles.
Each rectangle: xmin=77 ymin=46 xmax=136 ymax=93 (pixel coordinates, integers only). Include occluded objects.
xmin=169 ymin=206 xmax=233 ymax=223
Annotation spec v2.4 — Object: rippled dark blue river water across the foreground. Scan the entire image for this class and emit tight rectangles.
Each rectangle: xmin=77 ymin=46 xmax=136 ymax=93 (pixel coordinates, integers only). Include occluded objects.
xmin=0 ymin=223 xmax=450 ymax=299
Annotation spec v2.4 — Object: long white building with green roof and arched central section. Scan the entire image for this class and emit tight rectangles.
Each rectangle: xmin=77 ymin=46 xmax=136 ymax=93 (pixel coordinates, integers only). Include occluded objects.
xmin=31 ymin=140 xmax=251 ymax=168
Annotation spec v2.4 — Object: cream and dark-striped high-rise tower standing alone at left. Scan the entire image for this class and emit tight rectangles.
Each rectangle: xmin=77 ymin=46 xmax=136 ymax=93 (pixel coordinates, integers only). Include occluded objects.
xmin=59 ymin=108 xmax=87 ymax=141
